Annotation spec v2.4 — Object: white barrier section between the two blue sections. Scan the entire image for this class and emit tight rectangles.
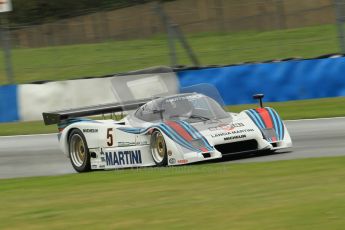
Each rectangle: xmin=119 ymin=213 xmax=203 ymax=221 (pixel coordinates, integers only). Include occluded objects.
xmin=18 ymin=73 xmax=178 ymax=121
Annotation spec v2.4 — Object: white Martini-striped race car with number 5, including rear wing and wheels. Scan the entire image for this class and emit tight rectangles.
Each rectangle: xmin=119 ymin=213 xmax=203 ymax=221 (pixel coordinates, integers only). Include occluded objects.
xmin=43 ymin=93 xmax=292 ymax=172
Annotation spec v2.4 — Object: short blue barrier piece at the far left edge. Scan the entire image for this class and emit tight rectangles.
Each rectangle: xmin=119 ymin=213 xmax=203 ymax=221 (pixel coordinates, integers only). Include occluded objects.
xmin=0 ymin=85 xmax=19 ymax=122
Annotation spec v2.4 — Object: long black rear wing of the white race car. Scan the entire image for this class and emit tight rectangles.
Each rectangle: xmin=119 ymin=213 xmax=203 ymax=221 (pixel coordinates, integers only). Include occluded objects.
xmin=42 ymin=99 xmax=152 ymax=125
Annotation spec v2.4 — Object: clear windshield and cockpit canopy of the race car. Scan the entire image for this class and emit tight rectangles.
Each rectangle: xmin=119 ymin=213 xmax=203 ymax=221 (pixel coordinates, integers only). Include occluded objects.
xmin=135 ymin=94 xmax=229 ymax=123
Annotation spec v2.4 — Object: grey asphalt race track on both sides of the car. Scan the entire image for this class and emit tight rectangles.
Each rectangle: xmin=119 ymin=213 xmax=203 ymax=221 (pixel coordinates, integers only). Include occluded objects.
xmin=0 ymin=117 xmax=345 ymax=178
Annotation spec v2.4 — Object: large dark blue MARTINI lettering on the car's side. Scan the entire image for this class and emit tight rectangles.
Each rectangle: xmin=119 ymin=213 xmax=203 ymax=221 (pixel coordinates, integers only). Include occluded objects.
xmin=105 ymin=150 xmax=142 ymax=165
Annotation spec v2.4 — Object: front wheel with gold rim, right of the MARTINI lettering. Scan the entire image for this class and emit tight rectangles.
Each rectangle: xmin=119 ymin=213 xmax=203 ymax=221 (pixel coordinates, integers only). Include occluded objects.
xmin=151 ymin=130 xmax=168 ymax=166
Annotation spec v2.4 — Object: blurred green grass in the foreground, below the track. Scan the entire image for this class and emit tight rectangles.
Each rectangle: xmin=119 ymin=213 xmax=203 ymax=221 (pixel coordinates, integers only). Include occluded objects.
xmin=0 ymin=157 xmax=345 ymax=230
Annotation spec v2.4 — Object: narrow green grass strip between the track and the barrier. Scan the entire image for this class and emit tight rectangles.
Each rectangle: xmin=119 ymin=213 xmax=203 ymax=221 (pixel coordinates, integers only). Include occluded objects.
xmin=0 ymin=97 xmax=345 ymax=136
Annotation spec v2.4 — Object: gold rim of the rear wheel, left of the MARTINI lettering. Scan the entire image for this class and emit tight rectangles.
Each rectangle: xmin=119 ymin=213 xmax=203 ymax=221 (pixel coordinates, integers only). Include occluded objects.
xmin=70 ymin=134 xmax=86 ymax=167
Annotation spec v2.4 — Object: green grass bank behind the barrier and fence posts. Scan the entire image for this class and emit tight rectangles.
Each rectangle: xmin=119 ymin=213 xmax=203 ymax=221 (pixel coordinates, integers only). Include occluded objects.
xmin=0 ymin=25 xmax=339 ymax=84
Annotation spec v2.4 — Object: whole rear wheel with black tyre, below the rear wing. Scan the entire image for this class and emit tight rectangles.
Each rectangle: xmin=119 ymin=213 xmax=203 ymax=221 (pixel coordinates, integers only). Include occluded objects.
xmin=68 ymin=129 xmax=91 ymax=172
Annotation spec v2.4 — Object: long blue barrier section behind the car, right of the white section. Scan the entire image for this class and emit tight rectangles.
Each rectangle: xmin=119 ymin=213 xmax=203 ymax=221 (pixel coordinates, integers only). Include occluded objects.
xmin=177 ymin=57 xmax=345 ymax=105
